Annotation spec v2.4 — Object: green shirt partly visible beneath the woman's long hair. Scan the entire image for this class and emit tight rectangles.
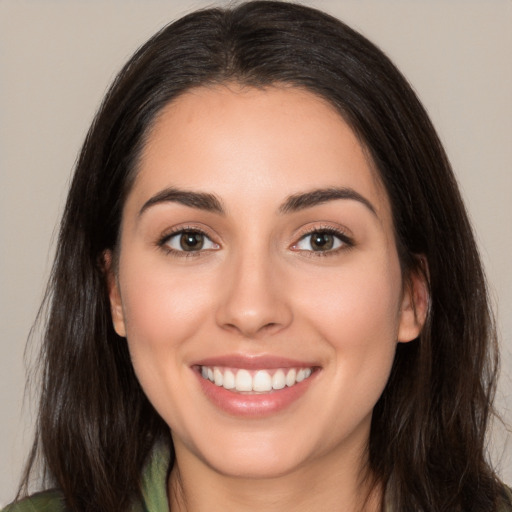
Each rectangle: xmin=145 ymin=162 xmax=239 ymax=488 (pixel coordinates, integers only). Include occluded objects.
xmin=1 ymin=449 xmax=512 ymax=512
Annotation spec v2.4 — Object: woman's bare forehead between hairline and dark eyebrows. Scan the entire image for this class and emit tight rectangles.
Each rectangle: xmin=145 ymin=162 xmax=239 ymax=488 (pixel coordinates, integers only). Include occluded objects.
xmin=133 ymin=84 xmax=388 ymax=219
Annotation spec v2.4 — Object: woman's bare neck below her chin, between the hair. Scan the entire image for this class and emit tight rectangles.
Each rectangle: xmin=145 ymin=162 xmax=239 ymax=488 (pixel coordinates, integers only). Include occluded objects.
xmin=169 ymin=442 xmax=382 ymax=512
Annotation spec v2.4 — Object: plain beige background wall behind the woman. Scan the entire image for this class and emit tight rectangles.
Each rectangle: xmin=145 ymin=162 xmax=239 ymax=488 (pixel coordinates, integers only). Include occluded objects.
xmin=0 ymin=0 xmax=512 ymax=504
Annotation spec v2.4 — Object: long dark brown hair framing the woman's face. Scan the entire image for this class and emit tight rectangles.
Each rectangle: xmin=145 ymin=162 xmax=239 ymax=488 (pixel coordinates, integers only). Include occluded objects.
xmin=19 ymin=1 xmax=504 ymax=512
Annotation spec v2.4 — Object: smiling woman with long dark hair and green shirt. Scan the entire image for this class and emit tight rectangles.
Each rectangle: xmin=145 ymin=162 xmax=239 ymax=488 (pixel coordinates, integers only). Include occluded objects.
xmin=5 ymin=2 xmax=511 ymax=511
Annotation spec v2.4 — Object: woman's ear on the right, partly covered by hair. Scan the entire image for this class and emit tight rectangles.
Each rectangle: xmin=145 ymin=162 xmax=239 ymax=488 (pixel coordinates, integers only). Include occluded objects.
xmin=398 ymin=257 xmax=430 ymax=343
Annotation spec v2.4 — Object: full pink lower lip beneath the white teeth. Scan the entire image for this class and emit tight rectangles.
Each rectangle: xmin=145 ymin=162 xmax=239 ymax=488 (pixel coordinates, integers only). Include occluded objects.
xmin=194 ymin=371 xmax=318 ymax=417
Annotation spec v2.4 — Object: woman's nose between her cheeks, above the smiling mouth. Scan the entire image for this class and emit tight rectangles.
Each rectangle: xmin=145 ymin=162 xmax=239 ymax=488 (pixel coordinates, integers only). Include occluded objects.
xmin=216 ymin=252 xmax=293 ymax=339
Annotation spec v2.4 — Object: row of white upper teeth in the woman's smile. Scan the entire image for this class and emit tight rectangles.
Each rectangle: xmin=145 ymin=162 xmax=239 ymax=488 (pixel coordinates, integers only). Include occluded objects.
xmin=201 ymin=366 xmax=312 ymax=393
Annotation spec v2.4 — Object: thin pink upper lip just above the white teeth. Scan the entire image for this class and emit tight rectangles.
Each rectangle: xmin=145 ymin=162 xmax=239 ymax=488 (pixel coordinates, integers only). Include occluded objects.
xmin=192 ymin=354 xmax=319 ymax=370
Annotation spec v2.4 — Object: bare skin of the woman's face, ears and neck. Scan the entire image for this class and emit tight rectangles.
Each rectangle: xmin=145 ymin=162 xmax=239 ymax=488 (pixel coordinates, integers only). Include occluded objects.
xmin=107 ymin=84 xmax=427 ymax=512
